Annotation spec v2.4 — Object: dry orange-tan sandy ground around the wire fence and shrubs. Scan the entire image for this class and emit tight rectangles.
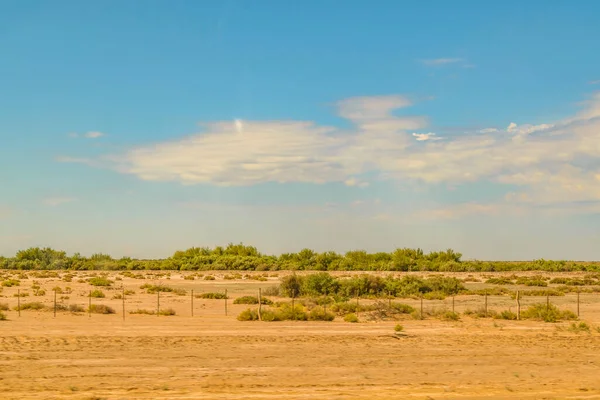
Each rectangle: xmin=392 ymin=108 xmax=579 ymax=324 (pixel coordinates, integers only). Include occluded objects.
xmin=0 ymin=273 xmax=600 ymax=399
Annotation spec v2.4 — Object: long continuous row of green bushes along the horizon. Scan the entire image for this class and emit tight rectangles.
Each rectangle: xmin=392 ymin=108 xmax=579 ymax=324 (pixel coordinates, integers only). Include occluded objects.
xmin=0 ymin=244 xmax=600 ymax=272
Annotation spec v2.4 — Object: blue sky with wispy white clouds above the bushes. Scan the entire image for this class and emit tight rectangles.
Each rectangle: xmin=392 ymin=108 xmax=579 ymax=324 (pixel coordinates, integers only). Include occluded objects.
xmin=0 ymin=0 xmax=600 ymax=260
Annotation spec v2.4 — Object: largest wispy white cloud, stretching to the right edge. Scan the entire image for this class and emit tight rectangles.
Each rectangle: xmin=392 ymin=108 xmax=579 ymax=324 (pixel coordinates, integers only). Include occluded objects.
xmin=58 ymin=93 xmax=600 ymax=215
